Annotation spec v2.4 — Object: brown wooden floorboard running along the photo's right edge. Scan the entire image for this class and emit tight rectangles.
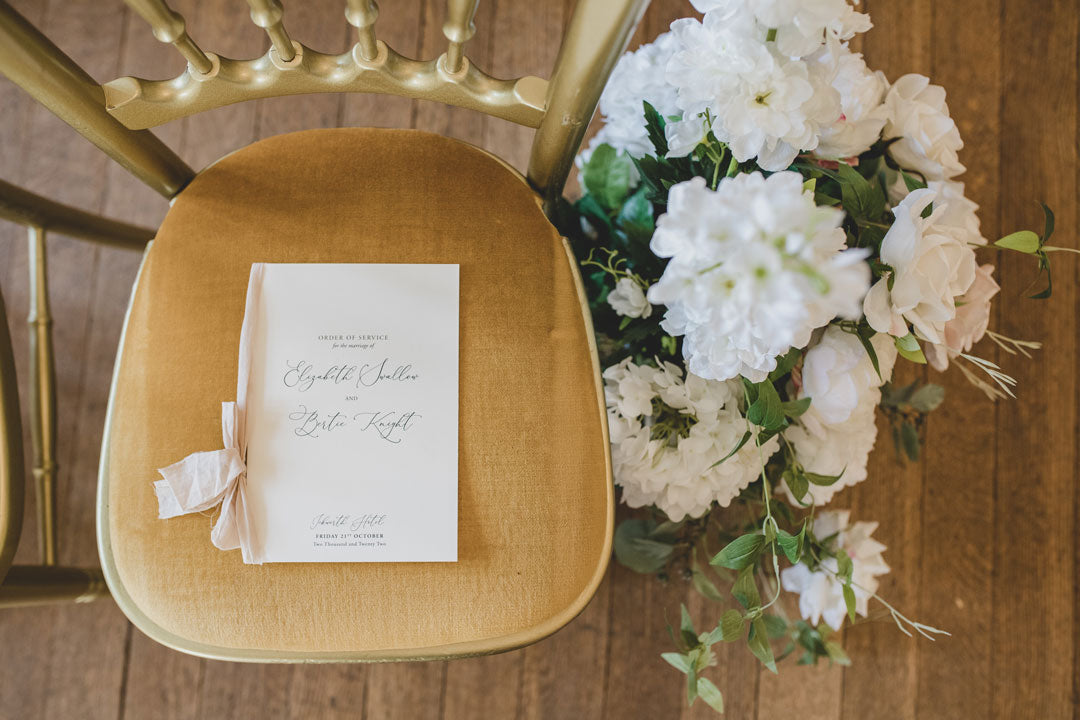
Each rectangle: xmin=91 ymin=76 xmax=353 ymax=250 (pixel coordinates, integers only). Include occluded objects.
xmin=991 ymin=0 xmax=1080 ymax=718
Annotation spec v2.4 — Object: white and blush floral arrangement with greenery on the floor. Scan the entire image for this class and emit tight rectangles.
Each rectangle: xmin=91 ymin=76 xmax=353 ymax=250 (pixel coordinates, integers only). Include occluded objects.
xmin=563 ymin=0 xmax=1067 ymax=710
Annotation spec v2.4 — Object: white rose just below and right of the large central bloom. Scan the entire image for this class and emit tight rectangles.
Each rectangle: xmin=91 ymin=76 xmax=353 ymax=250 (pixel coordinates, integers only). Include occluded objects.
xmin=780 ymin=325 xmax=896 ymax=505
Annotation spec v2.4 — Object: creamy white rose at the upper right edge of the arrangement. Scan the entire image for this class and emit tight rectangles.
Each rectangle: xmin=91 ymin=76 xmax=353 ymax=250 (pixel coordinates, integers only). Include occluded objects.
xmin=882 ymin=73 xmax=964 ymax=180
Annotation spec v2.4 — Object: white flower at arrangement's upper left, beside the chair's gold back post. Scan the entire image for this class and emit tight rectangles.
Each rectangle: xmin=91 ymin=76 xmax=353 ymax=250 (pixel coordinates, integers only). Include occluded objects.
xmin=578 ymin=32 xmax=679 ymax=167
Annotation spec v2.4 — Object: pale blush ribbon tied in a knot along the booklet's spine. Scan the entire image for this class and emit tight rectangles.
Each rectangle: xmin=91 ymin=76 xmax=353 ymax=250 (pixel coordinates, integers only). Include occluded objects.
xmin=153 ymin=262 xmax=262 ymax=565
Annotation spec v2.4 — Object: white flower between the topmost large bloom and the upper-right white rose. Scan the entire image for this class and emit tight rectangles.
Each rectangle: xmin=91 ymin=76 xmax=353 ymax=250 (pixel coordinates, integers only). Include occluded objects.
xmin=814 ymin=47 xmax=888 ymax=160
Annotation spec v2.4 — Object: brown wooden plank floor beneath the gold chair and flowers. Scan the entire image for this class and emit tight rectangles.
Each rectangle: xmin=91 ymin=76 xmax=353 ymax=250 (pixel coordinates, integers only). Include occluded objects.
xmin=0 ymin=0 xmax=1080 ymax=720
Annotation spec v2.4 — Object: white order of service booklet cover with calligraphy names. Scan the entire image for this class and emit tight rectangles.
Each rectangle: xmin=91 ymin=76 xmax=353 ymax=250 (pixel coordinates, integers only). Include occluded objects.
xmin=240 ymin=264 xmax=458 ymax=562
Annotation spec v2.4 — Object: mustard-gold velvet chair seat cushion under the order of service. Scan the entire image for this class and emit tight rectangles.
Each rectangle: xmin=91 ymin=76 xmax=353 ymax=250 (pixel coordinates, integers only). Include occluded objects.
xmin=98 ymin=128 xmax=612 ymax=661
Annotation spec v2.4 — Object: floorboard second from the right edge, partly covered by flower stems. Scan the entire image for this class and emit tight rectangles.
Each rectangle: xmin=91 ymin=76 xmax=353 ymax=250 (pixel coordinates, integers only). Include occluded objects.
xmin=917 ymin=0 xmax=1002 ymax=718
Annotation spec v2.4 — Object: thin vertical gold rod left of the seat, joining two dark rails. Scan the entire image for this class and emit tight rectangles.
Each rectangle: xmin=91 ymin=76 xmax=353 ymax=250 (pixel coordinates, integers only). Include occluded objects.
xmin=27 ymin=226 xmax=56 ymax=566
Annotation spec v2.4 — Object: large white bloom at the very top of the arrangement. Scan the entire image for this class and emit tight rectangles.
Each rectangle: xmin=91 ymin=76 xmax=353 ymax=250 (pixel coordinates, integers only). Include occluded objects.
xmin=666 ymin=0 xmax=869 ymax=171
